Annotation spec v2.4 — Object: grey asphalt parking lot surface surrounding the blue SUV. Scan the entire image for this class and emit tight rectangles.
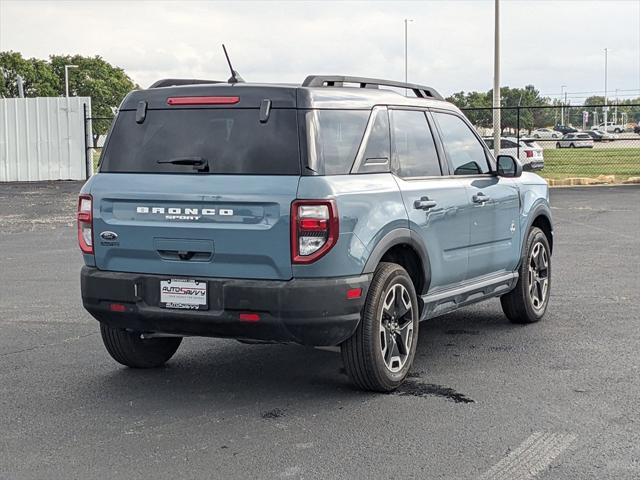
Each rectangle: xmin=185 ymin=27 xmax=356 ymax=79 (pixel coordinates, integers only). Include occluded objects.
xmin=0 ymin=182 xmax=640 ymax=480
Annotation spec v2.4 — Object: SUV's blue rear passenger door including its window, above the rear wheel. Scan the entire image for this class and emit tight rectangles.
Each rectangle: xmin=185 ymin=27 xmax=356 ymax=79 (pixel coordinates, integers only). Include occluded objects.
xmin=390 ymin=109 xmax=470 ymax=292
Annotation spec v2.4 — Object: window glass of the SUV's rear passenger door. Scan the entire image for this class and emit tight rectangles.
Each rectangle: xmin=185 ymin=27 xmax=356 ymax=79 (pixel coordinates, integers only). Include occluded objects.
xmin=391 ymin=110 xmax=442 ymax=177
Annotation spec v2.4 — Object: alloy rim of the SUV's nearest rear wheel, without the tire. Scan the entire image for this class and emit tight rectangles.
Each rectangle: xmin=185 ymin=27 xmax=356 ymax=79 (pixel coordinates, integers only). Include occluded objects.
xmin=380 ymin=283 xmax=413 ymax=373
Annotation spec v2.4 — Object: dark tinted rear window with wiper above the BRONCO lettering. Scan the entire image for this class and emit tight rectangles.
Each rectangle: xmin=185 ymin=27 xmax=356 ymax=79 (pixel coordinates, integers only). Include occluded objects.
xmin=100 ymin=108 xmax=300 ymax=175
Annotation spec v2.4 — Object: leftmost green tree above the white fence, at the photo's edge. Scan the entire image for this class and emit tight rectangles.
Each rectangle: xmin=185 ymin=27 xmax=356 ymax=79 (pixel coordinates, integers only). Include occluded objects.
xmin=0 ymin=51 xmax=60 ymax=98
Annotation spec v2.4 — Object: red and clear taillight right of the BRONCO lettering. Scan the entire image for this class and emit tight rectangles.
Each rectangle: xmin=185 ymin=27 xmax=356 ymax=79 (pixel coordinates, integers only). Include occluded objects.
xmin=291 ymin=200 xmax=339 ymax=264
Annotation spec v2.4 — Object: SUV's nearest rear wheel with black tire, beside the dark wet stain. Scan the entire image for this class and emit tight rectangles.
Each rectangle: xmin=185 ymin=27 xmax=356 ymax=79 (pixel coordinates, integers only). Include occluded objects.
xmin=341 ymin=262 xmax=419 ymax=392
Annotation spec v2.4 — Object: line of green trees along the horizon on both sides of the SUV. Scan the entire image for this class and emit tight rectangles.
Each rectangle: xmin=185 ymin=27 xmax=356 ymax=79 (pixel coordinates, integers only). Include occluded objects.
xmin=0 ymin=51 xmax=640 ymax=134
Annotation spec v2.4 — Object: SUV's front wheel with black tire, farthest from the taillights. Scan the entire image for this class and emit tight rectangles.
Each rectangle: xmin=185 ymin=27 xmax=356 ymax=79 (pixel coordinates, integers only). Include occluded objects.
xmin=500 ymin=227 xmax=551 ymax=323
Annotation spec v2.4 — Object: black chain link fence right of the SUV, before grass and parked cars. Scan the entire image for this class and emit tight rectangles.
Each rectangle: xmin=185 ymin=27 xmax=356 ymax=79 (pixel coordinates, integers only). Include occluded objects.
xmin=462 ymin=104 xmax=640 ymax=184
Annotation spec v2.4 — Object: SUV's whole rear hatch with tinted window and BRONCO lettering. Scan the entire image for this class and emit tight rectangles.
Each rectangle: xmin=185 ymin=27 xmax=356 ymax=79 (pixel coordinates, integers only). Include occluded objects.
xmin=90 ymin=86 xmax=300 ymax=279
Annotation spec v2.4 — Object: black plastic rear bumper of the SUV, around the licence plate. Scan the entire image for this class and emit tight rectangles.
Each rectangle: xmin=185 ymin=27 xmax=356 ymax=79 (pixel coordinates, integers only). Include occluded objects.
xmin=81 ymin=266 xmax=371 ymax=346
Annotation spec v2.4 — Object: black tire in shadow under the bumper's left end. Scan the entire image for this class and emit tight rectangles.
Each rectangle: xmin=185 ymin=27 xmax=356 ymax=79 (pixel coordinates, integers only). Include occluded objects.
xmin=100 ymin=323 xmax=182 ymax=368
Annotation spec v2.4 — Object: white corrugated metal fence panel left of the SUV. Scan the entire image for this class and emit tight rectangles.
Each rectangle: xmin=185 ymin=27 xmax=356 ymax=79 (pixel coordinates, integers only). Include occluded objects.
xmin=0 ymin=97 xmax=91 ymax=182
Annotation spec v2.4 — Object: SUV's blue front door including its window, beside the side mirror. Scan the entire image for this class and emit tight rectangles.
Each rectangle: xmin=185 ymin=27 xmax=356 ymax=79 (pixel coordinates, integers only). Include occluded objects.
xmin=433 ymin=111 xmax=520 ymax=279
